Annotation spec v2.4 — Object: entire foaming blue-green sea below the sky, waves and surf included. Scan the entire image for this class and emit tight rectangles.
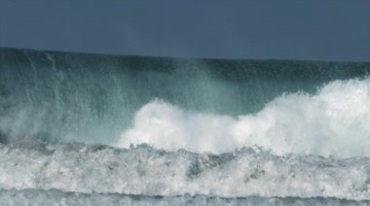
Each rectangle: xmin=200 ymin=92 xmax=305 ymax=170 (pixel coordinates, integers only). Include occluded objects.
xmin=0 ymin=48 xmax=370 ymax=205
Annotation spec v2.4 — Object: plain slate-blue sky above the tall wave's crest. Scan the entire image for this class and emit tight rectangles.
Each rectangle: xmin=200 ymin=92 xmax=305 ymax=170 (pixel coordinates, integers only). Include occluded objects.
xmin=0 ymin=0 xmax=370 ymax=61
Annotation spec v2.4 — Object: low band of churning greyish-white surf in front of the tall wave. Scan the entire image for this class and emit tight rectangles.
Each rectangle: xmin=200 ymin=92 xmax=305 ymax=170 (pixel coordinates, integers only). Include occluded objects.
xmin=0 ymin=143 xmax=370 ymax=200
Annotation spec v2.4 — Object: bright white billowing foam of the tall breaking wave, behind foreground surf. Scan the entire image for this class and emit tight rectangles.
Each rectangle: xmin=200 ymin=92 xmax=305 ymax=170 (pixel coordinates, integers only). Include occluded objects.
xmin=116 ymin=78 xmax=370 ymax=158
